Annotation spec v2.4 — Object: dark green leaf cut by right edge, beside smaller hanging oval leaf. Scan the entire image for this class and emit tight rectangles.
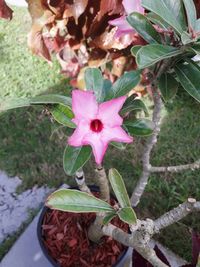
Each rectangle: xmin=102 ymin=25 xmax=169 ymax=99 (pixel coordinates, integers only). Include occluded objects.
xmin=175 ymin=61 xmax=200 ymax=102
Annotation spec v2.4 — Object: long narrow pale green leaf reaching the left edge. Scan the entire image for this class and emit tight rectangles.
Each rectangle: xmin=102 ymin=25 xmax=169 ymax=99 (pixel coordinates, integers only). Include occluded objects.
xmin=0 ymin=95 xmax=71 ymax=112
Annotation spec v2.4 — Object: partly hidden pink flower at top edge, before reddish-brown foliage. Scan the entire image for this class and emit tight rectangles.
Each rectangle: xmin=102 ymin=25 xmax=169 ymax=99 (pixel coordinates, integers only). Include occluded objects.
xmin=109 ymin=0 xmax=144 ymax=37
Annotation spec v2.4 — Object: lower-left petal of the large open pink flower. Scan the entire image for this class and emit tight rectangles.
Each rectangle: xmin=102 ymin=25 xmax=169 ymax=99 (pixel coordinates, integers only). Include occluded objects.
xmin=68 ymin=120 xmax=90 ymax=147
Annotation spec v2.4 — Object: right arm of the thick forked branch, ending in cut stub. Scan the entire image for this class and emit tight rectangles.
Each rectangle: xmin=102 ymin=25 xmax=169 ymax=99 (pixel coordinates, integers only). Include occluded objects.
xmin=154 ymin=198 xmax=200 ymax=232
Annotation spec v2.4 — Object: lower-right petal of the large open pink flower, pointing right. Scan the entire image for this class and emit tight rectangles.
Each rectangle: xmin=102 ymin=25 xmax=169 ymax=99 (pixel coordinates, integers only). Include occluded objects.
xmin=101 ymin=126 xmax=133 ymax=143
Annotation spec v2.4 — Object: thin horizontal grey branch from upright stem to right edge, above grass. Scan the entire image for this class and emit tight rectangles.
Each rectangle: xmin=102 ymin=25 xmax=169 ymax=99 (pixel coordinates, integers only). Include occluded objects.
xmin=150 ymin=160 xmax=200 ymax=172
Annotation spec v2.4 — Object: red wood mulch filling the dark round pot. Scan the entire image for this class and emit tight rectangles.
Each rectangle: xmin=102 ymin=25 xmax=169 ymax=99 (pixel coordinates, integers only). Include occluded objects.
xmin=43 ymin=196 xmax=128 ymax=267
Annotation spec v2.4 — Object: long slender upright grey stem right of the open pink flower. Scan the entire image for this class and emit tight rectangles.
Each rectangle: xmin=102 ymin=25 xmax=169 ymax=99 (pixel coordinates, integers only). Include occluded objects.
xmin=131 ymin=88 xmax=162 ymax=207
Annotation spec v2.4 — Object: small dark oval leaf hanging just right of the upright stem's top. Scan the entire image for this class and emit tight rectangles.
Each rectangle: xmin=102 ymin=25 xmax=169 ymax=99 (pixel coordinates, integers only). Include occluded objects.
xmin=158 ymin=73 xmax=179 ymax=102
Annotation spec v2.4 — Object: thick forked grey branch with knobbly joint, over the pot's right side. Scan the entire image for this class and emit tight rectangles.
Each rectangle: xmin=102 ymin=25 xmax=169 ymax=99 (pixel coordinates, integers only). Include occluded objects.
xmin=102 ymin=198 xmax=200 ymax=267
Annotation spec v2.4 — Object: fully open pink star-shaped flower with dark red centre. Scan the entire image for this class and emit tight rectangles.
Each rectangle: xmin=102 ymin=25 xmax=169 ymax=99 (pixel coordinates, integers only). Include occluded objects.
xmin=68 ymin=90 xmax=133 ymax=164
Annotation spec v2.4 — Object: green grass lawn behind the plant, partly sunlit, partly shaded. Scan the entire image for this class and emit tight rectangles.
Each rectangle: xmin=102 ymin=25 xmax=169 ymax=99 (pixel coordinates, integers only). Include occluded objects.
xmin=0 ymin=5 xmax=200 ymax=264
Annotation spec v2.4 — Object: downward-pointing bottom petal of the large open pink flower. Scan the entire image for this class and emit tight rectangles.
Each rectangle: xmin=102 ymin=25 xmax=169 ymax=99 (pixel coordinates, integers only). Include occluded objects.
xmin=84 ymin=132 xmax=108 ymax=164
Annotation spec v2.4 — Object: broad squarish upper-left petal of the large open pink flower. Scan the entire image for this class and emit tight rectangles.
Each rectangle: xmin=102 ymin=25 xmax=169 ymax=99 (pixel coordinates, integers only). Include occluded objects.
xmin=72 ymin=90 xmax=98 ymax=121
